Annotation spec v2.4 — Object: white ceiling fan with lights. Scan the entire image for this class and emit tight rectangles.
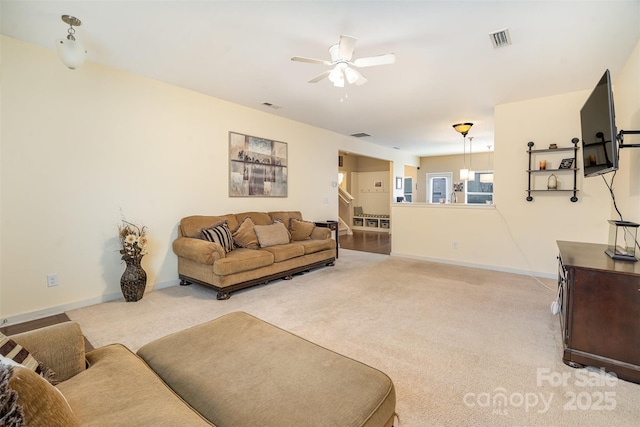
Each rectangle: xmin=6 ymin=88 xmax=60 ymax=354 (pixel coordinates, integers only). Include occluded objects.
xmin=291 ymin=36 xmax=396 ymax=87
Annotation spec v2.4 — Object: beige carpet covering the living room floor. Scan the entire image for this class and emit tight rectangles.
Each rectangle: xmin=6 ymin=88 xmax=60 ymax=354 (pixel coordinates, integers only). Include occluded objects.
xmin=67 ymin=250 xmax=640 ymax=427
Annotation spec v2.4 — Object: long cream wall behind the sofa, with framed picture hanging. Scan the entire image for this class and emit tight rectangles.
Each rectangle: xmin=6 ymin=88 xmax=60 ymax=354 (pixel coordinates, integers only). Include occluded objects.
xmin=0 ymin=36 xmax=418 ymax=323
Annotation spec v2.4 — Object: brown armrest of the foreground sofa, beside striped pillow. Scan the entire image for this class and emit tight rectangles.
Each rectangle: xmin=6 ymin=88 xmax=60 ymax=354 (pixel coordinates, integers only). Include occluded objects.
xmin=11 ymin=322 xmax=86 ymax=382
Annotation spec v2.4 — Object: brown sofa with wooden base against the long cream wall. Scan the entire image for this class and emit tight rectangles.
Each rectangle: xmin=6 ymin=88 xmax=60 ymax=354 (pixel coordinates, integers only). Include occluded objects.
xmin=173 ymin=211 xmax=336 ymax=299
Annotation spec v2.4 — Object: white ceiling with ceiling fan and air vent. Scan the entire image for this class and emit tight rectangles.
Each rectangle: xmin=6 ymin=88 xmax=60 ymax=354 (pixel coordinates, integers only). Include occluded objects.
xmin=0 ymin=0 xmax=640 ymax=155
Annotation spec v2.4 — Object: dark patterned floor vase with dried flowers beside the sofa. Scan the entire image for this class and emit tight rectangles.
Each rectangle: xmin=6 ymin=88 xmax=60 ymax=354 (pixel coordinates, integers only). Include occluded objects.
xmin=118 ymin=220 xmax=147 ymax=302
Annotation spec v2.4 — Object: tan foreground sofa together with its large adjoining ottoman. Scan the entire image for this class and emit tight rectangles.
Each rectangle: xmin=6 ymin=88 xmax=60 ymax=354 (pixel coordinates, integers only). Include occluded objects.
xmin=3 ymin=312 xmax=395 ymax=427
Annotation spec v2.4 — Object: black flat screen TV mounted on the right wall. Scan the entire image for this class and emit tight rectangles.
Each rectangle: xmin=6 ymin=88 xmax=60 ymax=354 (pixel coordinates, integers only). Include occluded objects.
xmin=580 ymin=70 xmax=618 ymax=176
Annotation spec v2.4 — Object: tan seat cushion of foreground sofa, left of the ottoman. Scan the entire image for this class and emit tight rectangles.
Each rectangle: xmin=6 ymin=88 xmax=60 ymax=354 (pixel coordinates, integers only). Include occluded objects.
xmin=56 ymin=344 xmax=211 ymax=427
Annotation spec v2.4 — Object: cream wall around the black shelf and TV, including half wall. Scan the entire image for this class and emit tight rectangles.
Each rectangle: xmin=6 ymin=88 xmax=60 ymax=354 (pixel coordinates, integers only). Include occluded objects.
xmin=391 ymin=41 xmax=640 ymax=277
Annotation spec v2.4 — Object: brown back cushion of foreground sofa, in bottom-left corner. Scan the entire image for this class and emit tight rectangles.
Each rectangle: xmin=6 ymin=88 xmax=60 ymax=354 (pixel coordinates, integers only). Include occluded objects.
xmin=9 ymin=367 xmax=80 ymax=427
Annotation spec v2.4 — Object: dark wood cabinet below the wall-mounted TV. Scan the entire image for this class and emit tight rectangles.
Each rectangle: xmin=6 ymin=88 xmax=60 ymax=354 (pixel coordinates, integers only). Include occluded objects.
xmin=557 ymin=241 xmax=640 ymax=383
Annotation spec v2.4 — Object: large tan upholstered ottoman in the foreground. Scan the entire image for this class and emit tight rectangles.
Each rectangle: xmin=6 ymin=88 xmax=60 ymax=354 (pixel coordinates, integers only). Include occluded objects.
xmin=138 ymin=312 xmax=396 ymax=427
